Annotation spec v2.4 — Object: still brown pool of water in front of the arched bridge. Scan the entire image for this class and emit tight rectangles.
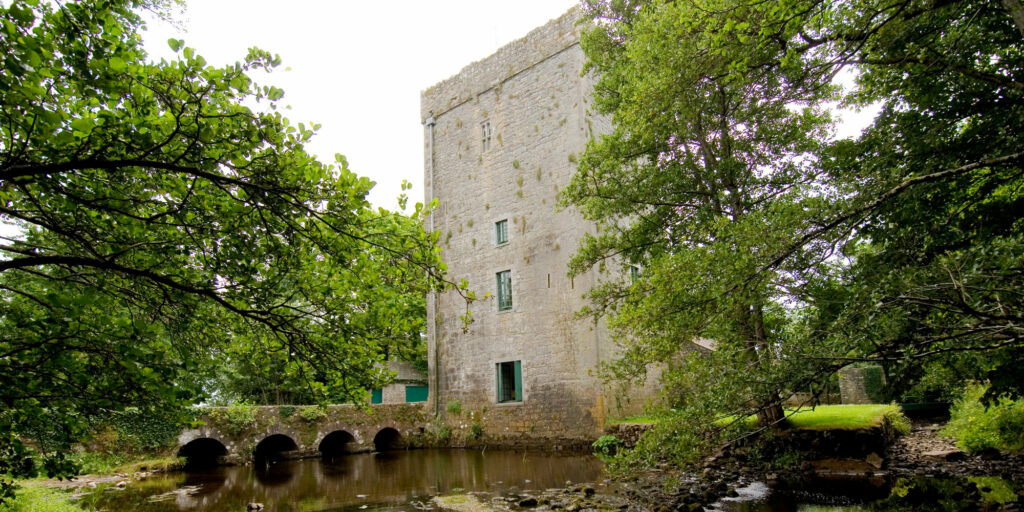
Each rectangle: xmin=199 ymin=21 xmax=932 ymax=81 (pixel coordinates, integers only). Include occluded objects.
xmin=84 ymin=450 xmax=602 ymax=511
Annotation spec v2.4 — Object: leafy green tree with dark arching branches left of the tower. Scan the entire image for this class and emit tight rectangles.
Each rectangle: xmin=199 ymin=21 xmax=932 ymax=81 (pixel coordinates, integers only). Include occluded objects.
xmin=0 ymin=0 xmax=443 ymax=493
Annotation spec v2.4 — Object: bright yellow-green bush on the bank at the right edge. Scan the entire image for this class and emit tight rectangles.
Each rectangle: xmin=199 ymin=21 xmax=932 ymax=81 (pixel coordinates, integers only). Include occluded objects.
xmin=942 ymin=384 xmax=1024 ymax=453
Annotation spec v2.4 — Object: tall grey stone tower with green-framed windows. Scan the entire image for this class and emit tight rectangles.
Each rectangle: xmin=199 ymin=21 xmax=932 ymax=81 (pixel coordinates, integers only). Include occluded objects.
xmin=421 ymin=9 xmax=642 ymax=443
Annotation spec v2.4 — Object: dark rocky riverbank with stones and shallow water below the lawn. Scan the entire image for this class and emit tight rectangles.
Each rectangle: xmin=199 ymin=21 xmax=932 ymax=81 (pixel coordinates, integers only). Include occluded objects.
xmin=596 ymin=422 xmax=1024 ymax=512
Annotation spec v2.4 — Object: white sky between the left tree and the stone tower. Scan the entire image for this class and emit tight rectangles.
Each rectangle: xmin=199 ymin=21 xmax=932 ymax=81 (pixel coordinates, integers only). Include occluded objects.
xmin=143 ymin=0 xmax=578 ymax=209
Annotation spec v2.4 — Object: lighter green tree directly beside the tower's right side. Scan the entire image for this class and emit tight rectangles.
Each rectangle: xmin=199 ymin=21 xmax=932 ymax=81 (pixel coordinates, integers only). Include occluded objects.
xmin=562 ymin=2 xmax=833 ymax=432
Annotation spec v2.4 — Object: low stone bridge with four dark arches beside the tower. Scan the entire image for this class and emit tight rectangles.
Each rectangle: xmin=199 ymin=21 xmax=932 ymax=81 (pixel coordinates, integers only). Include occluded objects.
xmin=176 ymin=403 xmax=430 ymax=466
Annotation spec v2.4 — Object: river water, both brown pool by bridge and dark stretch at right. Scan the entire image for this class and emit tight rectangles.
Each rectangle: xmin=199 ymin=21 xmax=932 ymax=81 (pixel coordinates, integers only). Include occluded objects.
xmin=70 ymin=450 xmax=1022 ymax=512
